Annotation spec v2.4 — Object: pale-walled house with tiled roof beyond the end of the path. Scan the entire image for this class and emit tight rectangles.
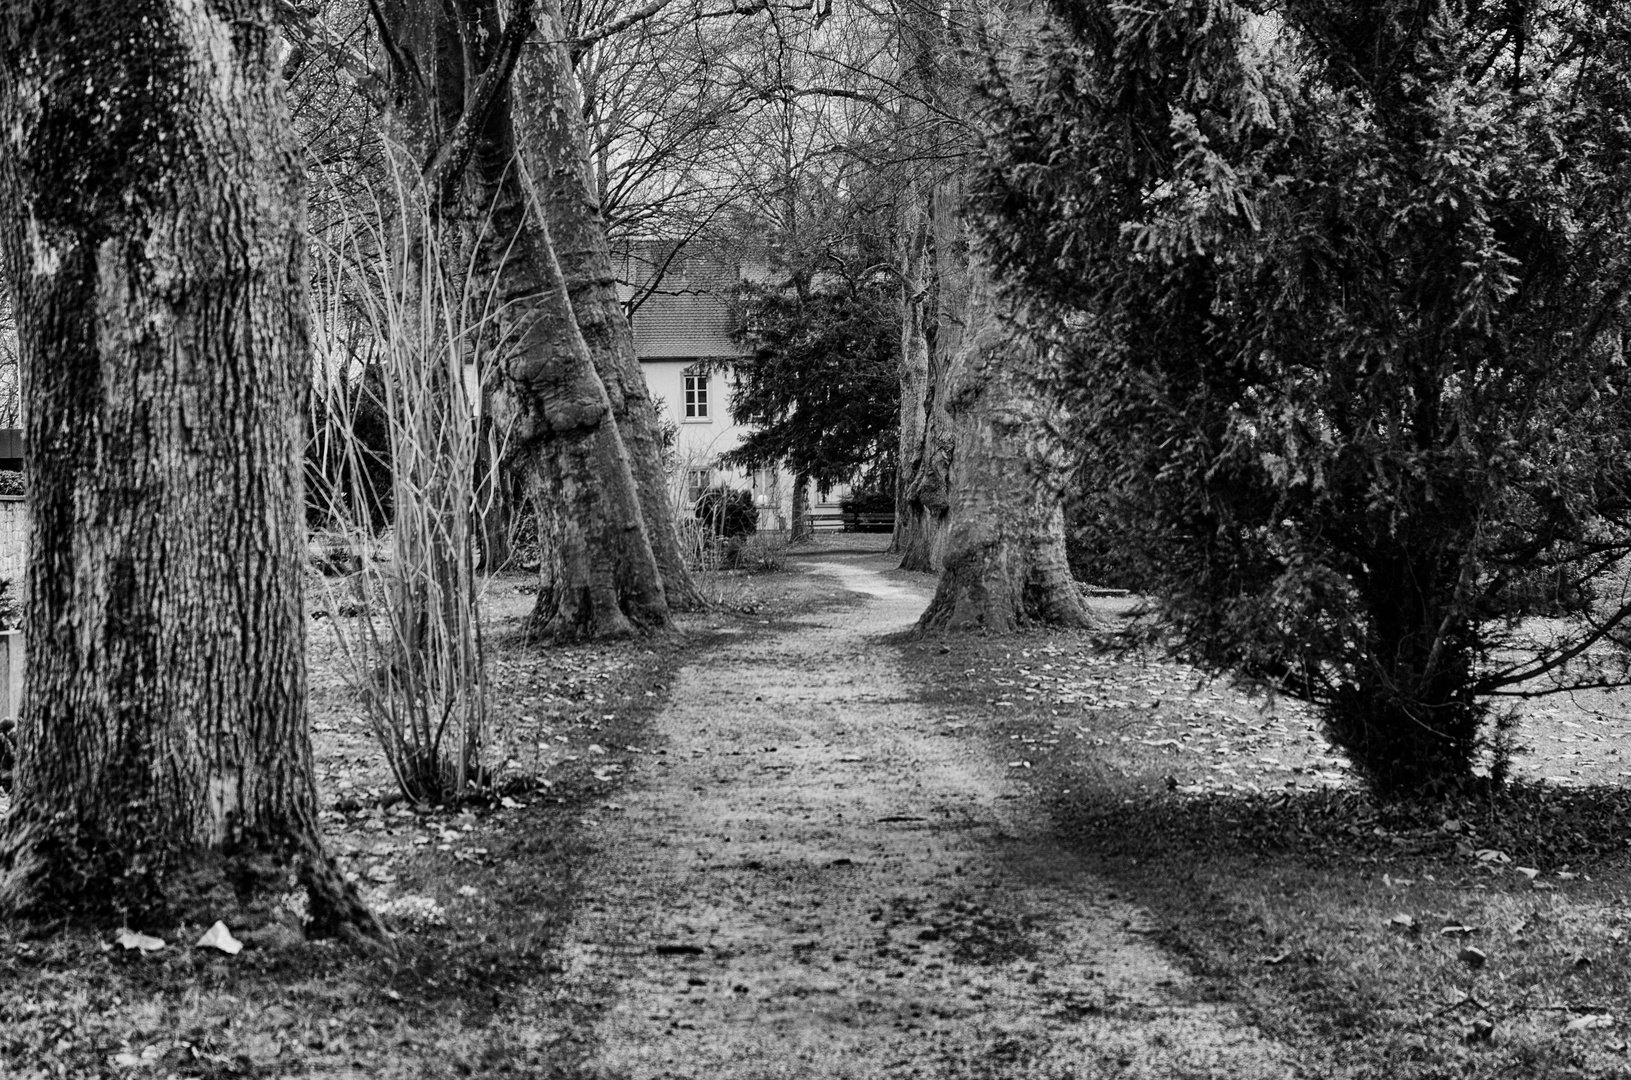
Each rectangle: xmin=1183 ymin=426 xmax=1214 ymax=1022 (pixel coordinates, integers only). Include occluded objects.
xmin=618 ymin=243 xmax=822 ymax=529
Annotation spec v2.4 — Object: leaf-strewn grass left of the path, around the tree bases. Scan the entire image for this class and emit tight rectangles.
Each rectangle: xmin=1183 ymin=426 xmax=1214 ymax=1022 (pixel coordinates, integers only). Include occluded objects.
xmin=0 ymin=561 xmax=802 ymax=1080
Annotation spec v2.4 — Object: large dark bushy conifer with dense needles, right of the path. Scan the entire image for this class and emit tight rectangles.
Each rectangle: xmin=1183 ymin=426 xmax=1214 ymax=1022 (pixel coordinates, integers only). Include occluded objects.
xmin=974 ymin=0 xmax=1631 ymax=795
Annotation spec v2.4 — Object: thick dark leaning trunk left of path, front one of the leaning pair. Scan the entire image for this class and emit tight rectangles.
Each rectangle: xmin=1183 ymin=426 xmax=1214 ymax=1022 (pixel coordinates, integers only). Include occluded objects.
xmin=385 ymin=0 xmax=669 ymax=640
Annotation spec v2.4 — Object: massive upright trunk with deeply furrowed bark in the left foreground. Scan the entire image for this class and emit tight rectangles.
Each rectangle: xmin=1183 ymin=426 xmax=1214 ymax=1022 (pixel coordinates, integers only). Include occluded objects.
xmin=0 ymin=0 xmax=380 ymax=933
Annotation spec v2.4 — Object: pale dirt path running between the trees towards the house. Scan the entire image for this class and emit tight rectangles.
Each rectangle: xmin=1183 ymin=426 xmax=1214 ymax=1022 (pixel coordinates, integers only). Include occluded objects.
xmin=568 ymin=556 xmax=1298 ymax=1080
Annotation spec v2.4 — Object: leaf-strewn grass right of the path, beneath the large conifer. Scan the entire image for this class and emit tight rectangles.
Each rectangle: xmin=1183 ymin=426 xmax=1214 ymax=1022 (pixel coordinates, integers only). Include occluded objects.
xmin=907 ymin=635 xmax=1631 ymax=1080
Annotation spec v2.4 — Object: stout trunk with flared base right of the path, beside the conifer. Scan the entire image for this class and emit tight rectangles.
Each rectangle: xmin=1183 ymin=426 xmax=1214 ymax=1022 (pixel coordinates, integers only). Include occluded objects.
xmin=918 ymin=259 xmax=1093 ymax=633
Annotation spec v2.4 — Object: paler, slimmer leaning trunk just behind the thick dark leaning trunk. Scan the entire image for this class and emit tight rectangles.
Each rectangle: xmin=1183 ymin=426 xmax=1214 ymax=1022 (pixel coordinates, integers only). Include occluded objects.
xmin=515 ymin=0 xmax=703 ymax=610
